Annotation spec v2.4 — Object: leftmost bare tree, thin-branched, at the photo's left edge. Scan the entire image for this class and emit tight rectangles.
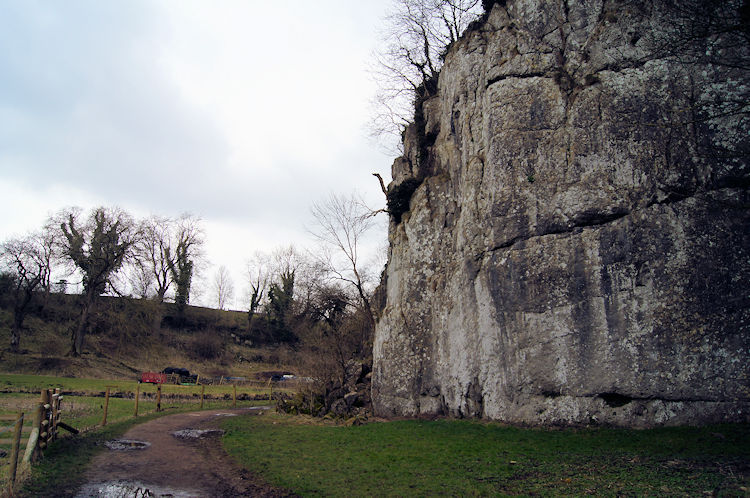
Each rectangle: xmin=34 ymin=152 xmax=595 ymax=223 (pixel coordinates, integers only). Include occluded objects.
xmin=0 ymin=234 xmax=52 ymax=353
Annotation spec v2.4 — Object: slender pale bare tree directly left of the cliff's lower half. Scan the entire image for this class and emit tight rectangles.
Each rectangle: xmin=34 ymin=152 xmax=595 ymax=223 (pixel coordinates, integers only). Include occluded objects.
xmin=309 ymin=194 xmax=382 ymax=336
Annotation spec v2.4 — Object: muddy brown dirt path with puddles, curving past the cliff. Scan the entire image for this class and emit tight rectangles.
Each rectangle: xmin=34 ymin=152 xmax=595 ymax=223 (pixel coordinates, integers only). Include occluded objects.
xmin=76 ymin=409 xmax=291 ymax=498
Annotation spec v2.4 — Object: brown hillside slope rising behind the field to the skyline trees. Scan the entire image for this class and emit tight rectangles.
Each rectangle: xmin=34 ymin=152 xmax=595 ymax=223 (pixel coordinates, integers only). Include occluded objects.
xmin=0 ymin=294 xmax=288 ymax=378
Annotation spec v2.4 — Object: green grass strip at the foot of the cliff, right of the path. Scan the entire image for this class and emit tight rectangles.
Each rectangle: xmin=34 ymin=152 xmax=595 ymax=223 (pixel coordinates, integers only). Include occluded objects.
xmin=223 ymin=415 xmax=750 ymax=496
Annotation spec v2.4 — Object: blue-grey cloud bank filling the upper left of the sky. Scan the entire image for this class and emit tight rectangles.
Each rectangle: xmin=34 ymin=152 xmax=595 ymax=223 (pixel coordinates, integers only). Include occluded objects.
xmin=0 ymin=1 xmax=228 ymax=216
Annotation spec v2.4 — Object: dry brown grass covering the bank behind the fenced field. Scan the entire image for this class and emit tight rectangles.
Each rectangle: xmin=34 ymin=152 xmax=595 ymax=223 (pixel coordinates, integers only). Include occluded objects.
xmin=0 ymin=309 xmax=308 ymax=379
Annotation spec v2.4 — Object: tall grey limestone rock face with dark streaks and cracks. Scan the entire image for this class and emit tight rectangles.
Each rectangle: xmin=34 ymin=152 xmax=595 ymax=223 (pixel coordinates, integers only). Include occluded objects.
xmin=372 ymin=0 xmax=750 ymax=427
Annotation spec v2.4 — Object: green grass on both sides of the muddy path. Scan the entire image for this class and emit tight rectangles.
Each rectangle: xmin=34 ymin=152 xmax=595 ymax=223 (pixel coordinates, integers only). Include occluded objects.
xmin=7 ymin=375 xmax=750 ymax=496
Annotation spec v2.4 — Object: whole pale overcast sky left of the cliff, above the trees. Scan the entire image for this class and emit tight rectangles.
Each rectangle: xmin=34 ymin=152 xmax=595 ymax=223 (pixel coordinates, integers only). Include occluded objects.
xmin=0 ymin=0 xmax=393 ymax=307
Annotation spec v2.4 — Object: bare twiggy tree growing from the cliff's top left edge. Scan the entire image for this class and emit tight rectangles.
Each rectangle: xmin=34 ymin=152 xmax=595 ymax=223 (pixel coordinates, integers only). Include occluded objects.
xmin=370 ymin=0 xmax=483 ymax=145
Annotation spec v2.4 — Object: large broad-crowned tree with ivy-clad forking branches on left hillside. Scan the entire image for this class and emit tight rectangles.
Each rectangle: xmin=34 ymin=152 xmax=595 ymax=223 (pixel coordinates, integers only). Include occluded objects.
xmin=57 ymin=207 xmax=139 ymax=356
